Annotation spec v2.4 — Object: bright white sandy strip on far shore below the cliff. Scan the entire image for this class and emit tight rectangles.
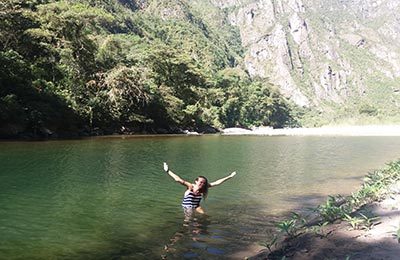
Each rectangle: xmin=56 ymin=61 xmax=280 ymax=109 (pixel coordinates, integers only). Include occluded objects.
xmin=221 ymin=125 xmax=400 ymax=136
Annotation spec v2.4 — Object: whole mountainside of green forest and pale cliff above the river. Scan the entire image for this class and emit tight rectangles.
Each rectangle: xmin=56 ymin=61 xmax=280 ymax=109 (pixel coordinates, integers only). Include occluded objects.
xmin=0 ymin=0 xmax=400 ymax=138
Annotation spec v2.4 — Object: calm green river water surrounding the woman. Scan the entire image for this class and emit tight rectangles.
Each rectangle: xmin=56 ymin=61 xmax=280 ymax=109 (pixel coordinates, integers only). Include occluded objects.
xmin=0 ymin=136 xmax=400 ymax=259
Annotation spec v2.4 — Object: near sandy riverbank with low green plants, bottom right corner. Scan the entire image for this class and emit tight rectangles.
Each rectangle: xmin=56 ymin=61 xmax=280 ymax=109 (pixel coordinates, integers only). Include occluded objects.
xmin=246 ymin=159 xmax=400 ymax=260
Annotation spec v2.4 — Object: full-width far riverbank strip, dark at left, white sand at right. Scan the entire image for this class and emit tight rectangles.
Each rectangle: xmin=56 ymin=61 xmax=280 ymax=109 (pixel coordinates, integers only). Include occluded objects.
xmin=0 ymin=125 xmax=400 ymax=141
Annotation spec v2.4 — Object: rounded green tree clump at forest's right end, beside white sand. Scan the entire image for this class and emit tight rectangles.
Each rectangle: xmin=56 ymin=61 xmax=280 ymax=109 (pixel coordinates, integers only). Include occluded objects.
xmin=208 ymin=68 xmax=292 ymax=127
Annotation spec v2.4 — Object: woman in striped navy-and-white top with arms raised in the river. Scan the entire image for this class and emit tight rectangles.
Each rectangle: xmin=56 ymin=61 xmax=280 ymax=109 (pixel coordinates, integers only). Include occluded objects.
xmin=164 ymin=162 xmax=236 ymax=214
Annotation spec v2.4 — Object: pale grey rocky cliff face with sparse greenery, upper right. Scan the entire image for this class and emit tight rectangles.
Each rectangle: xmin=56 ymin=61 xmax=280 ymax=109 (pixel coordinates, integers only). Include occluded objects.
xmin=212 ymin=0 xmax=400 ymax=114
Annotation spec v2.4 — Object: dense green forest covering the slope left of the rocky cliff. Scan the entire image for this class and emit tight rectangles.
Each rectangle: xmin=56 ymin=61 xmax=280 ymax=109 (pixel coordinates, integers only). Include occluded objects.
xmin=0 ymin=0 xmax=295 ymax=138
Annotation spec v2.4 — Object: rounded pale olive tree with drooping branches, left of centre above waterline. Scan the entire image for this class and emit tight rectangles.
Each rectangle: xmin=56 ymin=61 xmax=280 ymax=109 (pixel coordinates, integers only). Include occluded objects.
xmin=85 ymin=66 xmax=154 ymax=125
